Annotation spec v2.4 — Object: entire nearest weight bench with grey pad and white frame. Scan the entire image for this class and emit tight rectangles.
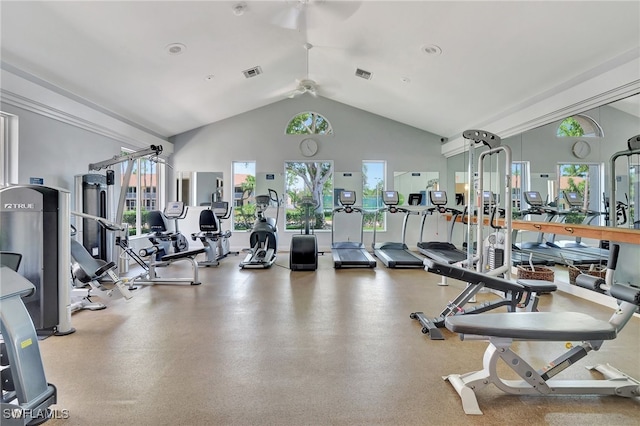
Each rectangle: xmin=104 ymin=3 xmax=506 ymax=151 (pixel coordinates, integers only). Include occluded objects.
xmin=443 ymin=245 xmax=640 ymax=414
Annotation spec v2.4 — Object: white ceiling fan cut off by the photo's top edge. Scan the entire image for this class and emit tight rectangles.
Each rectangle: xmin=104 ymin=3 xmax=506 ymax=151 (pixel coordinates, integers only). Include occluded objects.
xmin=272 ymin=0 xmax=362 ymax=30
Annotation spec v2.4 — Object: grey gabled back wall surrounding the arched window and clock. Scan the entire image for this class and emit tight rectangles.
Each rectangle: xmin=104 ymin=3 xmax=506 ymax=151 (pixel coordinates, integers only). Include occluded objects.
xmin=171 ymin=96 xmax=446 ymax=251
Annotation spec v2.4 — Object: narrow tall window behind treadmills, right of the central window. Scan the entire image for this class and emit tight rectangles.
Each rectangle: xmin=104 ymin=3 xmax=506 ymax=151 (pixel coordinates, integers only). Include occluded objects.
xmin=362 ymin=161 xmax=387 ymax=231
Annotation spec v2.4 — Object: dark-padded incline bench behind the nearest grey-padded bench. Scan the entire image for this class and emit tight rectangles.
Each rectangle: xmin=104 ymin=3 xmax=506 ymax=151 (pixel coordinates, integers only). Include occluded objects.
xmin=410 ymin=258 xmax=557 ymax=340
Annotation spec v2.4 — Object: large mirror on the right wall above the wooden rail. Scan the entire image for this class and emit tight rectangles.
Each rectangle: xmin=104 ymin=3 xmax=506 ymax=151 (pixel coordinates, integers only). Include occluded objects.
xmin=447 ymin=95 xmax=640 ymax=229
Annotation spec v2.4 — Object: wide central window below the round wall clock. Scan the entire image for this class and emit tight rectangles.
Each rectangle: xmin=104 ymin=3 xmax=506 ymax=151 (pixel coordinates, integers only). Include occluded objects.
xmin=284 ymin=161 xmax=333 ymax=230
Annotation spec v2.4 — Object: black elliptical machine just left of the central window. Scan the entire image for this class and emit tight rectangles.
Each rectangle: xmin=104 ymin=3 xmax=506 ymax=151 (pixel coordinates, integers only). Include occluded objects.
xmin=239 ymin=189 xmax=280 ymax=269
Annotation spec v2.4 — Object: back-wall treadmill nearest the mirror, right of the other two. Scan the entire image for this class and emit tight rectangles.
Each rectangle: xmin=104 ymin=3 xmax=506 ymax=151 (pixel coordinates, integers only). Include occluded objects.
xmin=418 ymin=191 xmax=467 ymax=265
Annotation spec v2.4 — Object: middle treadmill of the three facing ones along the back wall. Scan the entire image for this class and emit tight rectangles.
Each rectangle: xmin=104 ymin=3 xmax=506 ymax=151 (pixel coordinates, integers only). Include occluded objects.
xmin=372 ymin=191 xmax=424 ymax=268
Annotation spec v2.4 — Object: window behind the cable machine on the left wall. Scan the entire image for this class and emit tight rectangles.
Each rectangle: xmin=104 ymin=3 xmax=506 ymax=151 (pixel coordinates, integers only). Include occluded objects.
xmin=120 ymin=149 xmax=162 ymax=235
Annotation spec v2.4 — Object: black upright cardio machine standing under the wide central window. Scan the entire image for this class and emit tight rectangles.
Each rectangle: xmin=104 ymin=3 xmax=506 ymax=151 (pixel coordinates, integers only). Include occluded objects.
xmin=289 ymin=197 xmax=318 ymax=271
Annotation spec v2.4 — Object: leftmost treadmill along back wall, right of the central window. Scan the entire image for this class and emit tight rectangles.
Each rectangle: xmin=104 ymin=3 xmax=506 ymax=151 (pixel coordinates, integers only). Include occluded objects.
xmin=331 ymin=191 xmax=376 ymax=269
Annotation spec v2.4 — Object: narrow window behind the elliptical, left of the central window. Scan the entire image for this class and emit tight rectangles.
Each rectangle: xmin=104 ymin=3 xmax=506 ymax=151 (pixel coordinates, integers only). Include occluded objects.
xmin=232 ymin=161 xmax=256 ymax=231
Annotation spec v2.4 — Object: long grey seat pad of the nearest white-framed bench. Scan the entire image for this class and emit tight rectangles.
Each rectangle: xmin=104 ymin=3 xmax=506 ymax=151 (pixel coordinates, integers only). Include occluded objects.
xmin=445 ymin=312 xmax=617 ymax=342
